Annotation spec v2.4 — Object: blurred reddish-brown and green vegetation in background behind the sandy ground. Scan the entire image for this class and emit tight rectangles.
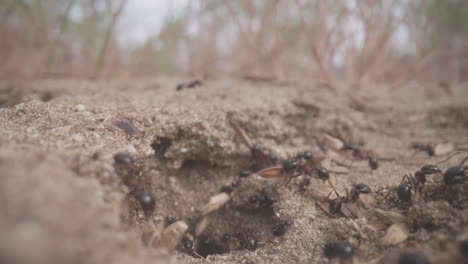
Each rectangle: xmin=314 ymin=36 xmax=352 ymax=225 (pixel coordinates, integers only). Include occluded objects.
xmin=0 ymin=0 xmax=468 ymax=87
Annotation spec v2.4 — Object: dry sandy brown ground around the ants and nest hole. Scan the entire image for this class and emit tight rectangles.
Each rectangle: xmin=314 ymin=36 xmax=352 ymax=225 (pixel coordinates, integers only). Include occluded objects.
xmin=0 ymin=78 xmax=468 ymax=263
